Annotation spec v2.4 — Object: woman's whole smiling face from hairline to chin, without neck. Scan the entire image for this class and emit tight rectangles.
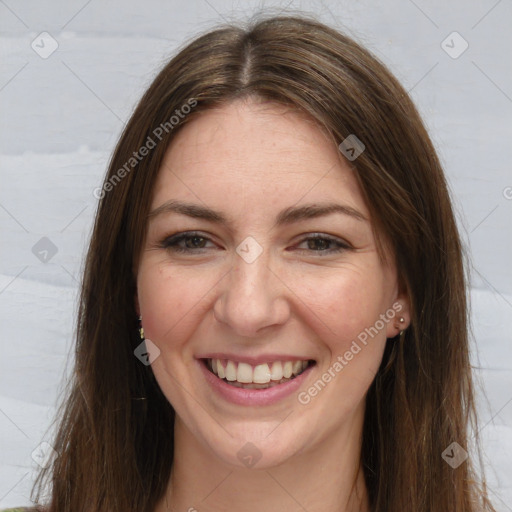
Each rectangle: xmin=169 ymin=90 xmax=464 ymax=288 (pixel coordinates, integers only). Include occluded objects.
xmin=137 ymin=100 xmax=408 ymax=468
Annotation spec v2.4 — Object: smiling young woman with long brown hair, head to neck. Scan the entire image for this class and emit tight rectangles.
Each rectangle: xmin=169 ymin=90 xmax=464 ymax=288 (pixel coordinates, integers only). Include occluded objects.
xmin=11 ymin=12 xmax=493 ymax=512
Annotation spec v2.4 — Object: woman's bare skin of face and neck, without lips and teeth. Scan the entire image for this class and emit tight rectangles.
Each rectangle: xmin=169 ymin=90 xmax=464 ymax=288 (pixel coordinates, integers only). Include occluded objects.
xmin=136 ymin=100 xmax=409 ymax=512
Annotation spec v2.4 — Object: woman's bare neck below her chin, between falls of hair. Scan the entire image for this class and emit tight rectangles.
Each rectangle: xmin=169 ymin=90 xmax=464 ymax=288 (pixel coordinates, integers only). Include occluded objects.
xmin=155 ymin=411 xmax=369 ymax=512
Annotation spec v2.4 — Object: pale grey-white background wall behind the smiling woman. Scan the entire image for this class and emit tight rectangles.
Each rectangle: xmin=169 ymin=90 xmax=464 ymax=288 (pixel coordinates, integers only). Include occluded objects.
xmin=0 ymin=0 xmax=512 ymax=512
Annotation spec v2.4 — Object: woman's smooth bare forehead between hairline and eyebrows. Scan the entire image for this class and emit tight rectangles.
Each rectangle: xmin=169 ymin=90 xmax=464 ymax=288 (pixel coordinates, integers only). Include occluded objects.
xmin=152 ymin=100 xmax=368 ymax=220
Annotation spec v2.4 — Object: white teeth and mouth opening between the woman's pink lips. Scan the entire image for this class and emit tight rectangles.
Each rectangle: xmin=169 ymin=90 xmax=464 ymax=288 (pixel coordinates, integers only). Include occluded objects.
xmin=202 ymin=359 xmax=315 ymax=389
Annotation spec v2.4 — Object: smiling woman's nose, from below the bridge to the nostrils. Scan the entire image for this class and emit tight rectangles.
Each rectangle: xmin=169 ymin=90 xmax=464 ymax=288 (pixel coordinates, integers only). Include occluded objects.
xmin=213 ymin=252 xmax=290 ymax=337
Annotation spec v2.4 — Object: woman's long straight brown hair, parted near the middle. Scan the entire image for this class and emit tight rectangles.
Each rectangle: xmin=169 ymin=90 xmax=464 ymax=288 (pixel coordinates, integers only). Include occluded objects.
xmin=34 ymin=16 xmax=493 ymax=512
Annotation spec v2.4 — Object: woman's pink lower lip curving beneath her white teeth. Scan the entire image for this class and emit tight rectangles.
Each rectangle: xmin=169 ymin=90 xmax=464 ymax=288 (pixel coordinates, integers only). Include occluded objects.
xmin=197 ymin=359 xmax=315 ymax=406
